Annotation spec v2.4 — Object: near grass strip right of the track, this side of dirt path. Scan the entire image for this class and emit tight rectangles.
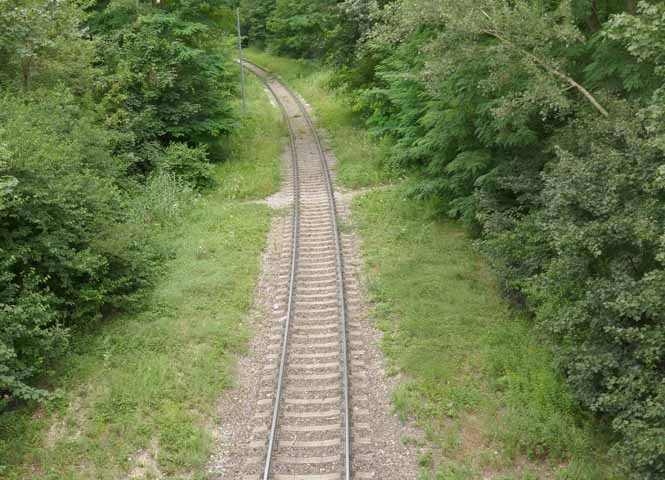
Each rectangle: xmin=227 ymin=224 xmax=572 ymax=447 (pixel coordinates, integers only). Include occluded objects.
xmin=353 ymin=187 xmax=616 ymax=480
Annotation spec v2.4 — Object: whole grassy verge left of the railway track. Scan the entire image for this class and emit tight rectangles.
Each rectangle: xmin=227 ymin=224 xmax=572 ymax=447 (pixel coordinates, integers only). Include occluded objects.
xmin=0 ymin=72 xmax=284 ymax=480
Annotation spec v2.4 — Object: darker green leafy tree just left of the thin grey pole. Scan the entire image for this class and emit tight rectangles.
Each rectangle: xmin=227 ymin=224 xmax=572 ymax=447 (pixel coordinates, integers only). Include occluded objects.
xmin=90 ymin=1 xmax=234 ymax=172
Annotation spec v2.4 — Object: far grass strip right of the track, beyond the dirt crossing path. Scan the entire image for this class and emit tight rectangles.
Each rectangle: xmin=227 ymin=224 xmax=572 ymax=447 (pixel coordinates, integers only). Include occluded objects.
xmin=246 ymin=48 xmax=399 ymax=189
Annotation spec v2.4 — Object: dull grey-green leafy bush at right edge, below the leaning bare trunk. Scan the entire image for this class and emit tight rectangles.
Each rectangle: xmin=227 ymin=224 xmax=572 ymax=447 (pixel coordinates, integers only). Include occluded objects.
xmin=527 ymin=106 xmax=665 ymax=478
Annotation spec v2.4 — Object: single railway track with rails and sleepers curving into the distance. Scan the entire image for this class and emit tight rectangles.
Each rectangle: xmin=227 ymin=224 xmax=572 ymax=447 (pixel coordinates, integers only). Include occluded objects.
xmin=237 ymin=63 xmax=373 ymax=480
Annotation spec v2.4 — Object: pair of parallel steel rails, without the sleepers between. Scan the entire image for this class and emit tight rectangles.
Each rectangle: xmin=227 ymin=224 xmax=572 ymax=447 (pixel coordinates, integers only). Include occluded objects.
xmin=245 ymin=60 xmax=351 ymax=480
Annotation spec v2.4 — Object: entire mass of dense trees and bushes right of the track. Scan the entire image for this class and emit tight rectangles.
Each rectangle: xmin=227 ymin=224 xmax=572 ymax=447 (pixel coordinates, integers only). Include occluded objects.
xmin=241 ymin=0 xmax=665 ymax=479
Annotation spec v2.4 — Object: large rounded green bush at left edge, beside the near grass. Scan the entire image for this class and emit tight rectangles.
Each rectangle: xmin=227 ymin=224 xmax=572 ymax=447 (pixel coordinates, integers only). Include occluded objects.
xmin=0 ymin=90 xmax=154 ymax=399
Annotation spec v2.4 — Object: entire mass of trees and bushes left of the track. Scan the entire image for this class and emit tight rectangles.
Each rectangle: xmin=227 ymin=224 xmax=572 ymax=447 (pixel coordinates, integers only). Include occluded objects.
xmin=0 ymin=0 xmax=235 ymax=411
